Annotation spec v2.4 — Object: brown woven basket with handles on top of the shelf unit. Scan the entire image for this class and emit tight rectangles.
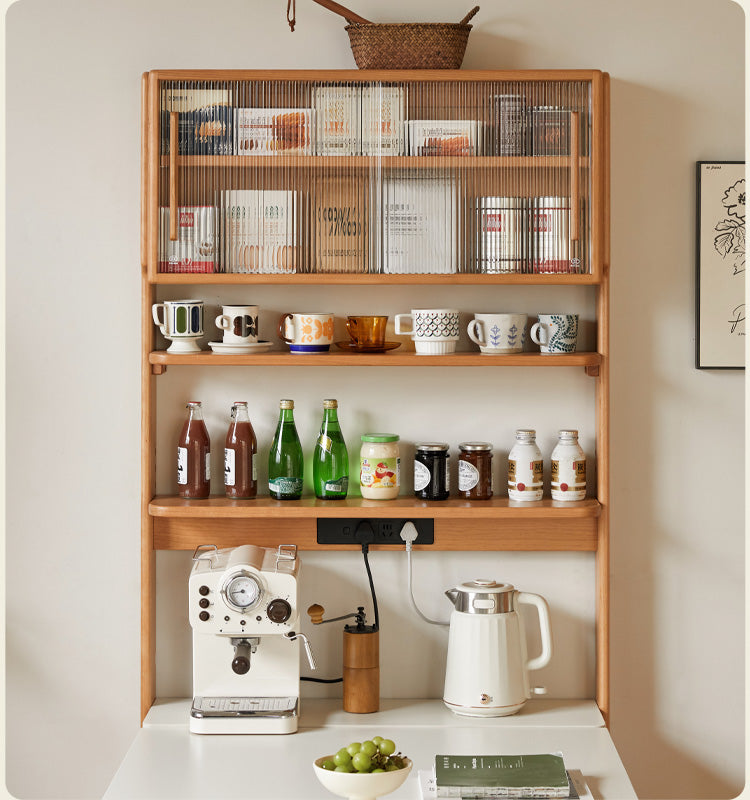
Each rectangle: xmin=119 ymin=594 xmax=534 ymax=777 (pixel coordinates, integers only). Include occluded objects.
xmin=308 ymin=0 xmax=479 ymax=69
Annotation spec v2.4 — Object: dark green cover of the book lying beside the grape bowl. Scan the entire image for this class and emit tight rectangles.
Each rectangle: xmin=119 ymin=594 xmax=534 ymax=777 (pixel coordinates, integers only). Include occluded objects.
xmin=435 ymin=753 xmax=568 ymax=797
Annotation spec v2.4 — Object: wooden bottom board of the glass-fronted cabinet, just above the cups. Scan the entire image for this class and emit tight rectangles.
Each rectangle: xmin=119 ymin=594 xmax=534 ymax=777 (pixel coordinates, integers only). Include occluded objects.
xmin=151 ymin=272 xmax=600 ymax=286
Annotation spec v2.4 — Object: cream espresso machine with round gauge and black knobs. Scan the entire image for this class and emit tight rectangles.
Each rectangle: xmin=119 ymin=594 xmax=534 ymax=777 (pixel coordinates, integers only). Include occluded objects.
xmin=188 ymin=544 xmax=315 ymax=733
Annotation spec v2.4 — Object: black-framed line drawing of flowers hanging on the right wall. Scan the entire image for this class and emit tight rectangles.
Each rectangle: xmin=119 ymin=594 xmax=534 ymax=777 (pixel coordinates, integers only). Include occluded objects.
xmin=695 ymin=161 xmax=745 ymax=369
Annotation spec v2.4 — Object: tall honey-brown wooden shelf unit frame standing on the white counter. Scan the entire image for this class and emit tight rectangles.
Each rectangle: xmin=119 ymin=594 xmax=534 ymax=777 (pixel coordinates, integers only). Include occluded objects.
xmin=141 ymin=70 xmax=610 ymax=721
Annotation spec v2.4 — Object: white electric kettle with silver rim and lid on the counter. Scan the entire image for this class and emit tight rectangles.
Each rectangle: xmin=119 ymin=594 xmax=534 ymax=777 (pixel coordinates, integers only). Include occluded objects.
xmin=443 ymin=578 xmax=552 ymax=717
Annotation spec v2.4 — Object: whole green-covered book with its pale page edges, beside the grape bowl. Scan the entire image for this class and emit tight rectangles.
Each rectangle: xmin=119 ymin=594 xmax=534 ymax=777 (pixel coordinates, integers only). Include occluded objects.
xmin=435 ymin=753 xmax=570 ymax=800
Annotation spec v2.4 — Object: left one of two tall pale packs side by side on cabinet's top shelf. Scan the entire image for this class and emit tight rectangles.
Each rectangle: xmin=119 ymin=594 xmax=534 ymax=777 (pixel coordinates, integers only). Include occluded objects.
xmin=312 ymin=86 xmax=362 ymax=156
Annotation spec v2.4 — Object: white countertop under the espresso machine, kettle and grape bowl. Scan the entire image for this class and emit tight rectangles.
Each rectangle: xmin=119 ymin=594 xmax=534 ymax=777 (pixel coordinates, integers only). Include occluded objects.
xmin=104 ymin=699 xmax=636 ymax=800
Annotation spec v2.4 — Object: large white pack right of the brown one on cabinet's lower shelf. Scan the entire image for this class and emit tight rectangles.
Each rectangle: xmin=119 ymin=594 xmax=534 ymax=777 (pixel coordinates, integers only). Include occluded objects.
xmin=384 ymin=175 xmax=458 ymax=274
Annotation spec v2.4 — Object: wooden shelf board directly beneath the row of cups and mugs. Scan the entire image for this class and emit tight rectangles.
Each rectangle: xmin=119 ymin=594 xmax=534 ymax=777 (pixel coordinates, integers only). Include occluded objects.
xmin=148 ymin=347 xmax=602 ymax=367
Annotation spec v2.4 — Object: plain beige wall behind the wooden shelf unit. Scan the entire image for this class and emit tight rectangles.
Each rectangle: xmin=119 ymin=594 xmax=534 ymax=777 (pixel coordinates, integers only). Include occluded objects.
xmin=6 ymin=0 xmax=745 ymax=798
